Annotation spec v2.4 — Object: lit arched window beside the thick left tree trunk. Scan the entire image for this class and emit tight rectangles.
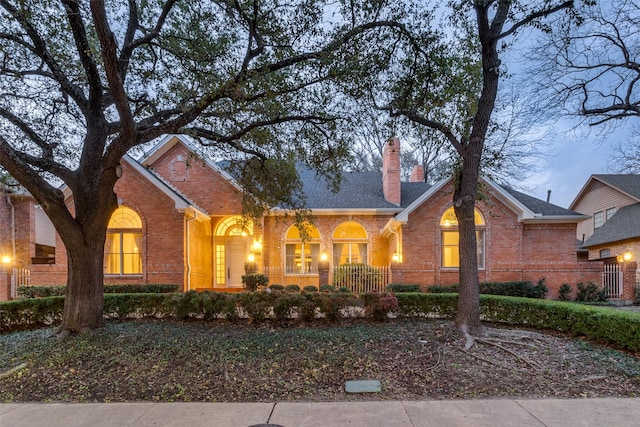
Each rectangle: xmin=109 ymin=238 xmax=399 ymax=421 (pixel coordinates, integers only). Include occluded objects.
xmin=104 ymin=206 xmax=142 ymax=275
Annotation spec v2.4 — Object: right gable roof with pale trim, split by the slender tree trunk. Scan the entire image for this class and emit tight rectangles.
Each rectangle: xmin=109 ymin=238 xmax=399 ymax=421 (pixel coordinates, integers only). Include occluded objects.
xmin=396 ymin=178 xmax=588 ymax=223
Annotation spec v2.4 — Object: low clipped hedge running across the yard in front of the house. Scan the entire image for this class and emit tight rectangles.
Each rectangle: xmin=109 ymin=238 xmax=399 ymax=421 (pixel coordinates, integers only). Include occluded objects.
xmin=0 ymin=290 xmax=640 ymax=352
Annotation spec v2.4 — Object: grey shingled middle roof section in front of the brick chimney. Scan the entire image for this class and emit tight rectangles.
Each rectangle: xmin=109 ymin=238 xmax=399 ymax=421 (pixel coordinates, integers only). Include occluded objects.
xmin=290 ymin=165 xmax=430 ymax=214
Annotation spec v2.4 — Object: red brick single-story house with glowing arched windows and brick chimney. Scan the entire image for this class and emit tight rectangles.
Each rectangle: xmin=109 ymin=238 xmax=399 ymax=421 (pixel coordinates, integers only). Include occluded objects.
xmin=0 ymin=136 xmax=602 ymax=298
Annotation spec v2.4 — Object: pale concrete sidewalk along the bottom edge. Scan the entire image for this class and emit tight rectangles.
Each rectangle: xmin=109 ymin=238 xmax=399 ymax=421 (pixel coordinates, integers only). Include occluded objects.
xmin=0 ymin=398 xmax=640 ymax=427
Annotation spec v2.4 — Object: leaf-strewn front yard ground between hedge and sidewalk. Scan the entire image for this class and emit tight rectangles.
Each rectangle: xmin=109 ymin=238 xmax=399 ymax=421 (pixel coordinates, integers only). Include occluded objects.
xmin=0 ymin=319 xmax=640 ymax=402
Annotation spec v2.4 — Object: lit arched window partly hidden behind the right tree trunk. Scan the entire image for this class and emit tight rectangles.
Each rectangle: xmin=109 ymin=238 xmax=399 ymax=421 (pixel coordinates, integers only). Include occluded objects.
xmin=440 ymin=206 xmax=485 ymax=268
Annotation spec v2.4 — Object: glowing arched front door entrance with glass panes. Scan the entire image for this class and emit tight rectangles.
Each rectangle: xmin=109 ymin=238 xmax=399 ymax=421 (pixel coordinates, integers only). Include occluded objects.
xmin=215 ymin=216 xmax=253 ymax=288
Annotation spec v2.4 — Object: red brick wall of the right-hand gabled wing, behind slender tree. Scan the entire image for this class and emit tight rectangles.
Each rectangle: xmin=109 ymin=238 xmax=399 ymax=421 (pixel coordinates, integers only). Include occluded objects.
xmin=393 ymin=185 xmax=602 ymax=298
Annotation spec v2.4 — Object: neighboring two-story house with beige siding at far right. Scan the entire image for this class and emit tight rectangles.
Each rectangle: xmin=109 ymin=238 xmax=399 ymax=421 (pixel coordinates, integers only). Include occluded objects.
xmin=569 ymin=174 xmax=640 ymax=300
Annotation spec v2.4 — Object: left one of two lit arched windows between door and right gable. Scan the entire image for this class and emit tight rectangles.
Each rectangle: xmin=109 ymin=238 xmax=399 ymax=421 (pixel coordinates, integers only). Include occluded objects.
xmin=285 ymin=223 xmax=320 ymax=274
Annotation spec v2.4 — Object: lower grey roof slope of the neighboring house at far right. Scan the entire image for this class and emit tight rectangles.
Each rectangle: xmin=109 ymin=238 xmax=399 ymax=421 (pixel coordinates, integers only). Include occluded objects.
xmin=582 ymin=203 xmax=640 ymax=248
